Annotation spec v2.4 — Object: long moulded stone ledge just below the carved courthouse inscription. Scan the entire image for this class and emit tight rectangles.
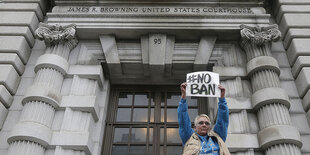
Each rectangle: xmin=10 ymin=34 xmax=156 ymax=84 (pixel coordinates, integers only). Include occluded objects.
xmin=47 ymin=13 xmax=270 ymax=29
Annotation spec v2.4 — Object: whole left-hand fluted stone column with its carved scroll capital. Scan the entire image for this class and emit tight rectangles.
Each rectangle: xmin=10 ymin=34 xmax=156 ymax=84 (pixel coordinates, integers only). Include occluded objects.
xmin=8 ymin=23 xmax=78 ymax=155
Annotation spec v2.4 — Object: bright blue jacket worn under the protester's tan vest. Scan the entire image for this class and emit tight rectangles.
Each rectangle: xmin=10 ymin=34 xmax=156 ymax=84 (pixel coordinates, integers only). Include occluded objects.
xmin=178 ymin=98 xmax=229 ymax=153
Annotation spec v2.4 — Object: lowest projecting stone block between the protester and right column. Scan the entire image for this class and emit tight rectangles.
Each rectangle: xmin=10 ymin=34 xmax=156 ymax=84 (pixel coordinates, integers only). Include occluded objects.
xmin=225 ymin=134 xmax=259 ymax=152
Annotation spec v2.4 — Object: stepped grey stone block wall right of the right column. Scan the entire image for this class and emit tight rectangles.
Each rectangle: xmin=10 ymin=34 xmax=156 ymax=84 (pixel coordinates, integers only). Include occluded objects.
xmin=273 ymin=0 xmax=310 ymax=154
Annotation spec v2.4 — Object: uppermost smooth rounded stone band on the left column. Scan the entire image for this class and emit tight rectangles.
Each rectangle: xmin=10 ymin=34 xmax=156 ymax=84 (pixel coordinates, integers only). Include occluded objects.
xmin=34 ymin=54 xmax=69 ymax=75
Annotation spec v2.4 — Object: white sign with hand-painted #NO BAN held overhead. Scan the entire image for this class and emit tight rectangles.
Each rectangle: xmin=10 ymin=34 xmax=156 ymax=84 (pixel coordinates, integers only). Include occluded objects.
xmin=186 ymin=72 xmax=221 ymax=97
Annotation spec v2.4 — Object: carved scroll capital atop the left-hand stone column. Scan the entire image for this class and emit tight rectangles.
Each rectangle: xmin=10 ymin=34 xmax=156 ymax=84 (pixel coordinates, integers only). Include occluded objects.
xmin=35 ymin=23 xmax=78 ymax=49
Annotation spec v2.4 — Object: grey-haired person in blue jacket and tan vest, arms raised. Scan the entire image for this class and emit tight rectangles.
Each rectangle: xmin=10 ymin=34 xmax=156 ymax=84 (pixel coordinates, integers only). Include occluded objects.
xmin=178 ymin=83 xmax=230 ymax=155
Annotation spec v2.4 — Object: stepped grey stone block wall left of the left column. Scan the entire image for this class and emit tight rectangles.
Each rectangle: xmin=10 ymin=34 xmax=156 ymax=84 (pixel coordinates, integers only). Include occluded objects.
xmin=0 ymin=0 xmax=47 ymax=154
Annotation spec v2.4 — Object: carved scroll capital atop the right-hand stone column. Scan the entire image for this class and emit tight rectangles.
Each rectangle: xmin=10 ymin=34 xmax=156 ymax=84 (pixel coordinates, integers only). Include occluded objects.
xmin=240 ymin=24 xmax=281 ymax=46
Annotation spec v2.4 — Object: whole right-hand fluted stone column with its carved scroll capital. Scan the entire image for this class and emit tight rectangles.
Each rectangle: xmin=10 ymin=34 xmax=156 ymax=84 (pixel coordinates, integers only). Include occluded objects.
xmin=241 ymin=25 xmax=302 ymax=155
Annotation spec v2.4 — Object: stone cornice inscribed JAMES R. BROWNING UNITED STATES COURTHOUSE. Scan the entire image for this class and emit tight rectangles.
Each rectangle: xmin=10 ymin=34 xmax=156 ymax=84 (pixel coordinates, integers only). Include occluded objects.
xmin=47 ymin=4 xmax=270 ymax=40
